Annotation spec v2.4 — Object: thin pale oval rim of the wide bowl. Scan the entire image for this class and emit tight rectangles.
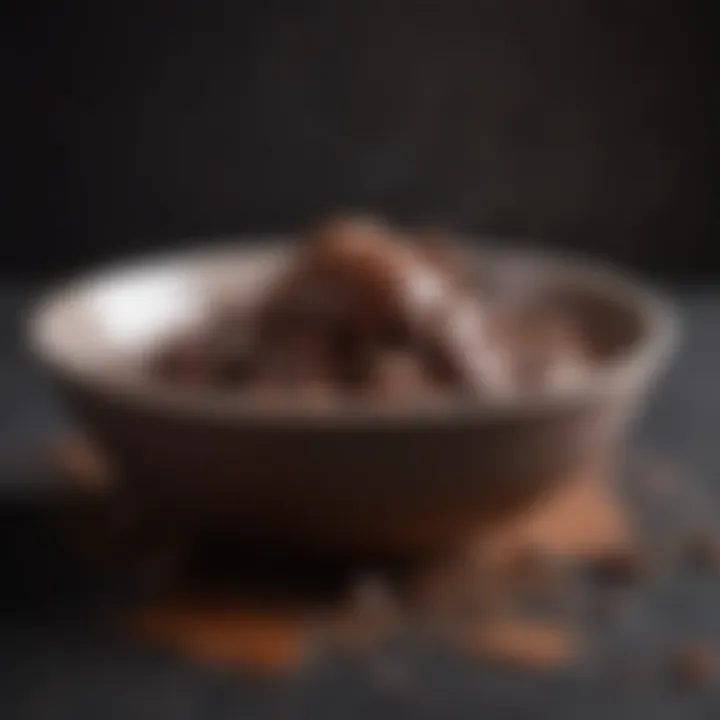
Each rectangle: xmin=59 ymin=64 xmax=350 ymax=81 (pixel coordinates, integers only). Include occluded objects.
xmin=26 ymin=235 xmax=680 ymax=429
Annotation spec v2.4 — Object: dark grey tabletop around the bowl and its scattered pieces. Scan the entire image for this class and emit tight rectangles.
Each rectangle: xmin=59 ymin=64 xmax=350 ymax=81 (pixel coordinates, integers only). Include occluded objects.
xmin=0 ymin=285 xmax=720 ymax=720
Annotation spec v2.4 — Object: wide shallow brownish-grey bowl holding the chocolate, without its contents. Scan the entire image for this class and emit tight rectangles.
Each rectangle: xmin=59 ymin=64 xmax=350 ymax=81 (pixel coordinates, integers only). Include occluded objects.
xmin=30 ymin=241 xmax=676 ymax=553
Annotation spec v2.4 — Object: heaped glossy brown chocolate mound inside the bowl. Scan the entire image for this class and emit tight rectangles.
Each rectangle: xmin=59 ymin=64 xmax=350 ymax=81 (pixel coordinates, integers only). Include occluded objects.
xmin=146 ymin=211 xmax=583 ymax=398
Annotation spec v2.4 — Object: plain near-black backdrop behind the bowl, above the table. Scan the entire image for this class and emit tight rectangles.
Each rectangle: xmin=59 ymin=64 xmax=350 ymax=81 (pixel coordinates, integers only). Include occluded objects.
xmin=0 ymin=0 xmax=720 ymax=279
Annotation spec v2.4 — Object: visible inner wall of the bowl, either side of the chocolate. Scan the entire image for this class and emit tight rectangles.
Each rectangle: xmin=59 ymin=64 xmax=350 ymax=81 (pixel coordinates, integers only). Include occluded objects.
xmin=32 ymin=243 xmax=669 ymax=414
